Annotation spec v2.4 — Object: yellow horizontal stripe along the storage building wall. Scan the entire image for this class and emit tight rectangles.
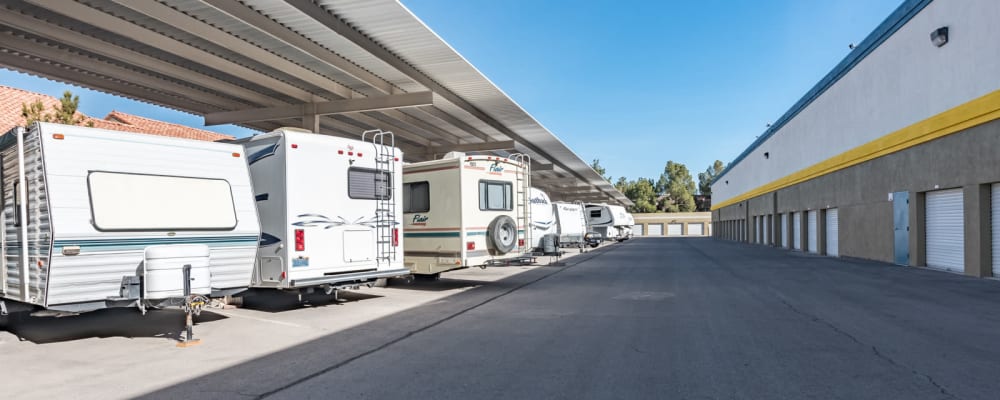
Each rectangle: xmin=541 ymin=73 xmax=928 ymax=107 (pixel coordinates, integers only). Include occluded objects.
xmin=712 ymin=90 xmax=1000 ymax=211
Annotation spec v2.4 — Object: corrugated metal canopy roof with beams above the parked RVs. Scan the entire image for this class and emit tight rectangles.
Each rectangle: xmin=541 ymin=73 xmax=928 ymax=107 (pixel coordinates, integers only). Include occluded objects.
xmin=0 ymin=0 xmax=632 ymax=205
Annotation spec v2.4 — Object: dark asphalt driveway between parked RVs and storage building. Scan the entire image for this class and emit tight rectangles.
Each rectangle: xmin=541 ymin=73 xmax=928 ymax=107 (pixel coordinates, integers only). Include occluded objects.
xmin=141 ymin=238 xmax=1000 ymax=399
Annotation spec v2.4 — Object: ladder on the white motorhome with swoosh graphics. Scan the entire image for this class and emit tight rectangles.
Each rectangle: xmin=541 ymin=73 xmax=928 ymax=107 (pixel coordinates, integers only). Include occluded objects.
xmin=361 ymin=129 xmax=398 ymax=266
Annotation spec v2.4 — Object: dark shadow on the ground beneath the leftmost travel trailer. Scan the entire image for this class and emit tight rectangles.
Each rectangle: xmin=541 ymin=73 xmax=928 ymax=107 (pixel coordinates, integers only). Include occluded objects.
xmin=0 ymin=308 xmax=227 ymax=344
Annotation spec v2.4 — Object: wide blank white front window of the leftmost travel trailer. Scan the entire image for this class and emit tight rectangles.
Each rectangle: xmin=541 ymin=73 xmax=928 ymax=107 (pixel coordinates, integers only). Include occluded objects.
xmin=87 ymin=172 xmax=236 ymax=231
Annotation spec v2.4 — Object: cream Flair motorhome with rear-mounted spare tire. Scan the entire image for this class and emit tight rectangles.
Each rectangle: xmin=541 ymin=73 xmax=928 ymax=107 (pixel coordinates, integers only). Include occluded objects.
xmin=403 ymin=152 xmax=534 ymax=275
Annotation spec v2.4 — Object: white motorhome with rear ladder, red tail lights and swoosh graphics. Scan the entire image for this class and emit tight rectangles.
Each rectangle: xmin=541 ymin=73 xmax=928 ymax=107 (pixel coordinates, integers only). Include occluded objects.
xmin=238 ymin=128 xmax=409 ymax=293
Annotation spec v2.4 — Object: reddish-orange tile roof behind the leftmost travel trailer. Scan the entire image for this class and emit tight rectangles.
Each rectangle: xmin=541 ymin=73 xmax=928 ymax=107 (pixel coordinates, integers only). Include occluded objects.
xmin=0 ymin=85 xmax=234 ymax=141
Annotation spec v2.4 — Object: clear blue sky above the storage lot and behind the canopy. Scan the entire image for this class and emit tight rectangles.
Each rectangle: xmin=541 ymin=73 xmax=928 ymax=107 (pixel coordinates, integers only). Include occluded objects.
xmin=0 ymin=0 xmax=901 ymax=179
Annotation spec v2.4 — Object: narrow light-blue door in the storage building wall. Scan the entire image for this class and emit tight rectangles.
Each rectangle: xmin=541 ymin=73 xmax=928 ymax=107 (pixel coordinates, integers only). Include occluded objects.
xmin=925 ymin=189 xmax=965 ymax=272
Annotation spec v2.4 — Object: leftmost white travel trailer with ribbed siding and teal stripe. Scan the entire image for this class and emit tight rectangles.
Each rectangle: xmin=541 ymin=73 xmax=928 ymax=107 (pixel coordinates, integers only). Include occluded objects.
xmin=0 ymin=123 xmax=260 ymax=314
